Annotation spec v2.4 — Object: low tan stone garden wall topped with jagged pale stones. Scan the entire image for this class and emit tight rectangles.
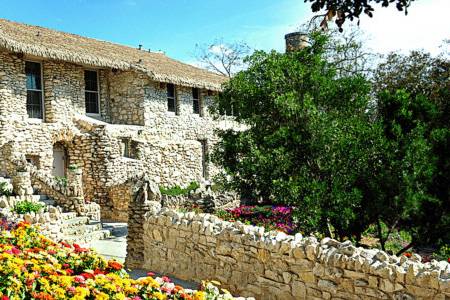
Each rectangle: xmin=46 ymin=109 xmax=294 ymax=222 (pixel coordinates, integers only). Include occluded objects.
xmin=127 ymin=207 xmax=450 ymax=300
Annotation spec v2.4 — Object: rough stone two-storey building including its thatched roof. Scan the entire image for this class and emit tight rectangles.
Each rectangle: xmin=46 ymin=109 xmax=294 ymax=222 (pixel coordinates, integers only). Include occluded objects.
xmin=0 ymin=19 xmax=231 ymax=219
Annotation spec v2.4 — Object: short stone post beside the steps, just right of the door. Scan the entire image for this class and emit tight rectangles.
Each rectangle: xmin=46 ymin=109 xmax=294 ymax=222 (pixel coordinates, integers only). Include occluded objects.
xmin=66 ymin=168 xmax=86 ymax=215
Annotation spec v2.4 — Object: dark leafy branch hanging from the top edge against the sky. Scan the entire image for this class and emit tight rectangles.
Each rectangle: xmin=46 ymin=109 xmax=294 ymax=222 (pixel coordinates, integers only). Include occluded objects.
xmin=304 ymin=0 xmax=414 ymax=31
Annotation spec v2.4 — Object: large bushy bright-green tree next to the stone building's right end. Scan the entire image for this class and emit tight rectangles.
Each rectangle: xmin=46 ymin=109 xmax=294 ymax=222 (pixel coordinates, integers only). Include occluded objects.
xmin=213 ymin=34 xmax=387 ymax=239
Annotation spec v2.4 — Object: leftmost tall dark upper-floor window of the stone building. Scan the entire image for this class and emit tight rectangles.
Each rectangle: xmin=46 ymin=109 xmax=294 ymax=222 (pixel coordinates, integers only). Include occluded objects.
xmin=25 ymin=61 xmax=44 ymax=119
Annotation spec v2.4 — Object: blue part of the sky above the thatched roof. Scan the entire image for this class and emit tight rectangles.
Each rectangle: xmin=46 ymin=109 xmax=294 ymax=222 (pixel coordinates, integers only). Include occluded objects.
xmin=0 ymin=0 xmax=308 ymax=61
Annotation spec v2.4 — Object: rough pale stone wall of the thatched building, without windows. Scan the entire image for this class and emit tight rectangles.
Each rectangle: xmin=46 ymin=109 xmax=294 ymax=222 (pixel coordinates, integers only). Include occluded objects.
xmin=0 ymin=50 xmax=239 ymax=218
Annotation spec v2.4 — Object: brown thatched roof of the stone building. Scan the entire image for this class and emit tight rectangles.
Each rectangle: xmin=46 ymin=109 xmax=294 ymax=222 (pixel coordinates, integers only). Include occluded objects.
xmin=0 ymin=19 xmax=226 ymax=90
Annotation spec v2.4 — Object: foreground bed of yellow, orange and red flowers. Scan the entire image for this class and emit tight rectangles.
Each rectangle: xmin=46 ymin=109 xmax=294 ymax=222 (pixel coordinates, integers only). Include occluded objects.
xmin=0 ymin=220 xmax=237 ymax=300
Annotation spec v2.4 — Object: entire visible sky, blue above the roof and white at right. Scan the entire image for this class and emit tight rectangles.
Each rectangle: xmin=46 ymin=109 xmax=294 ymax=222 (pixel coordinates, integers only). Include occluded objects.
xmin=0 ymin=0 xmax=450 ymax=63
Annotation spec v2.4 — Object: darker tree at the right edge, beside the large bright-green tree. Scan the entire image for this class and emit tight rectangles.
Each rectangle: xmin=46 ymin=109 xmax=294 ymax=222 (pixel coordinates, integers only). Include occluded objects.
xmin=374 ymin=51 xmax=450 ymax=251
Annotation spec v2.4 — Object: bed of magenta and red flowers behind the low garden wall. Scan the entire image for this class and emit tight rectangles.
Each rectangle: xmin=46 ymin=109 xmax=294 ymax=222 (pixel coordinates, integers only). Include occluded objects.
xmin=216 ymin=205 xmax=299 ymax=234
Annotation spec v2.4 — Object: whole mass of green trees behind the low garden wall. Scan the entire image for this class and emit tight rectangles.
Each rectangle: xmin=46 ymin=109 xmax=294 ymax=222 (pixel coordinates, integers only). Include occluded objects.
xmin=212 ymin=29 xmax=450 ymax=251
